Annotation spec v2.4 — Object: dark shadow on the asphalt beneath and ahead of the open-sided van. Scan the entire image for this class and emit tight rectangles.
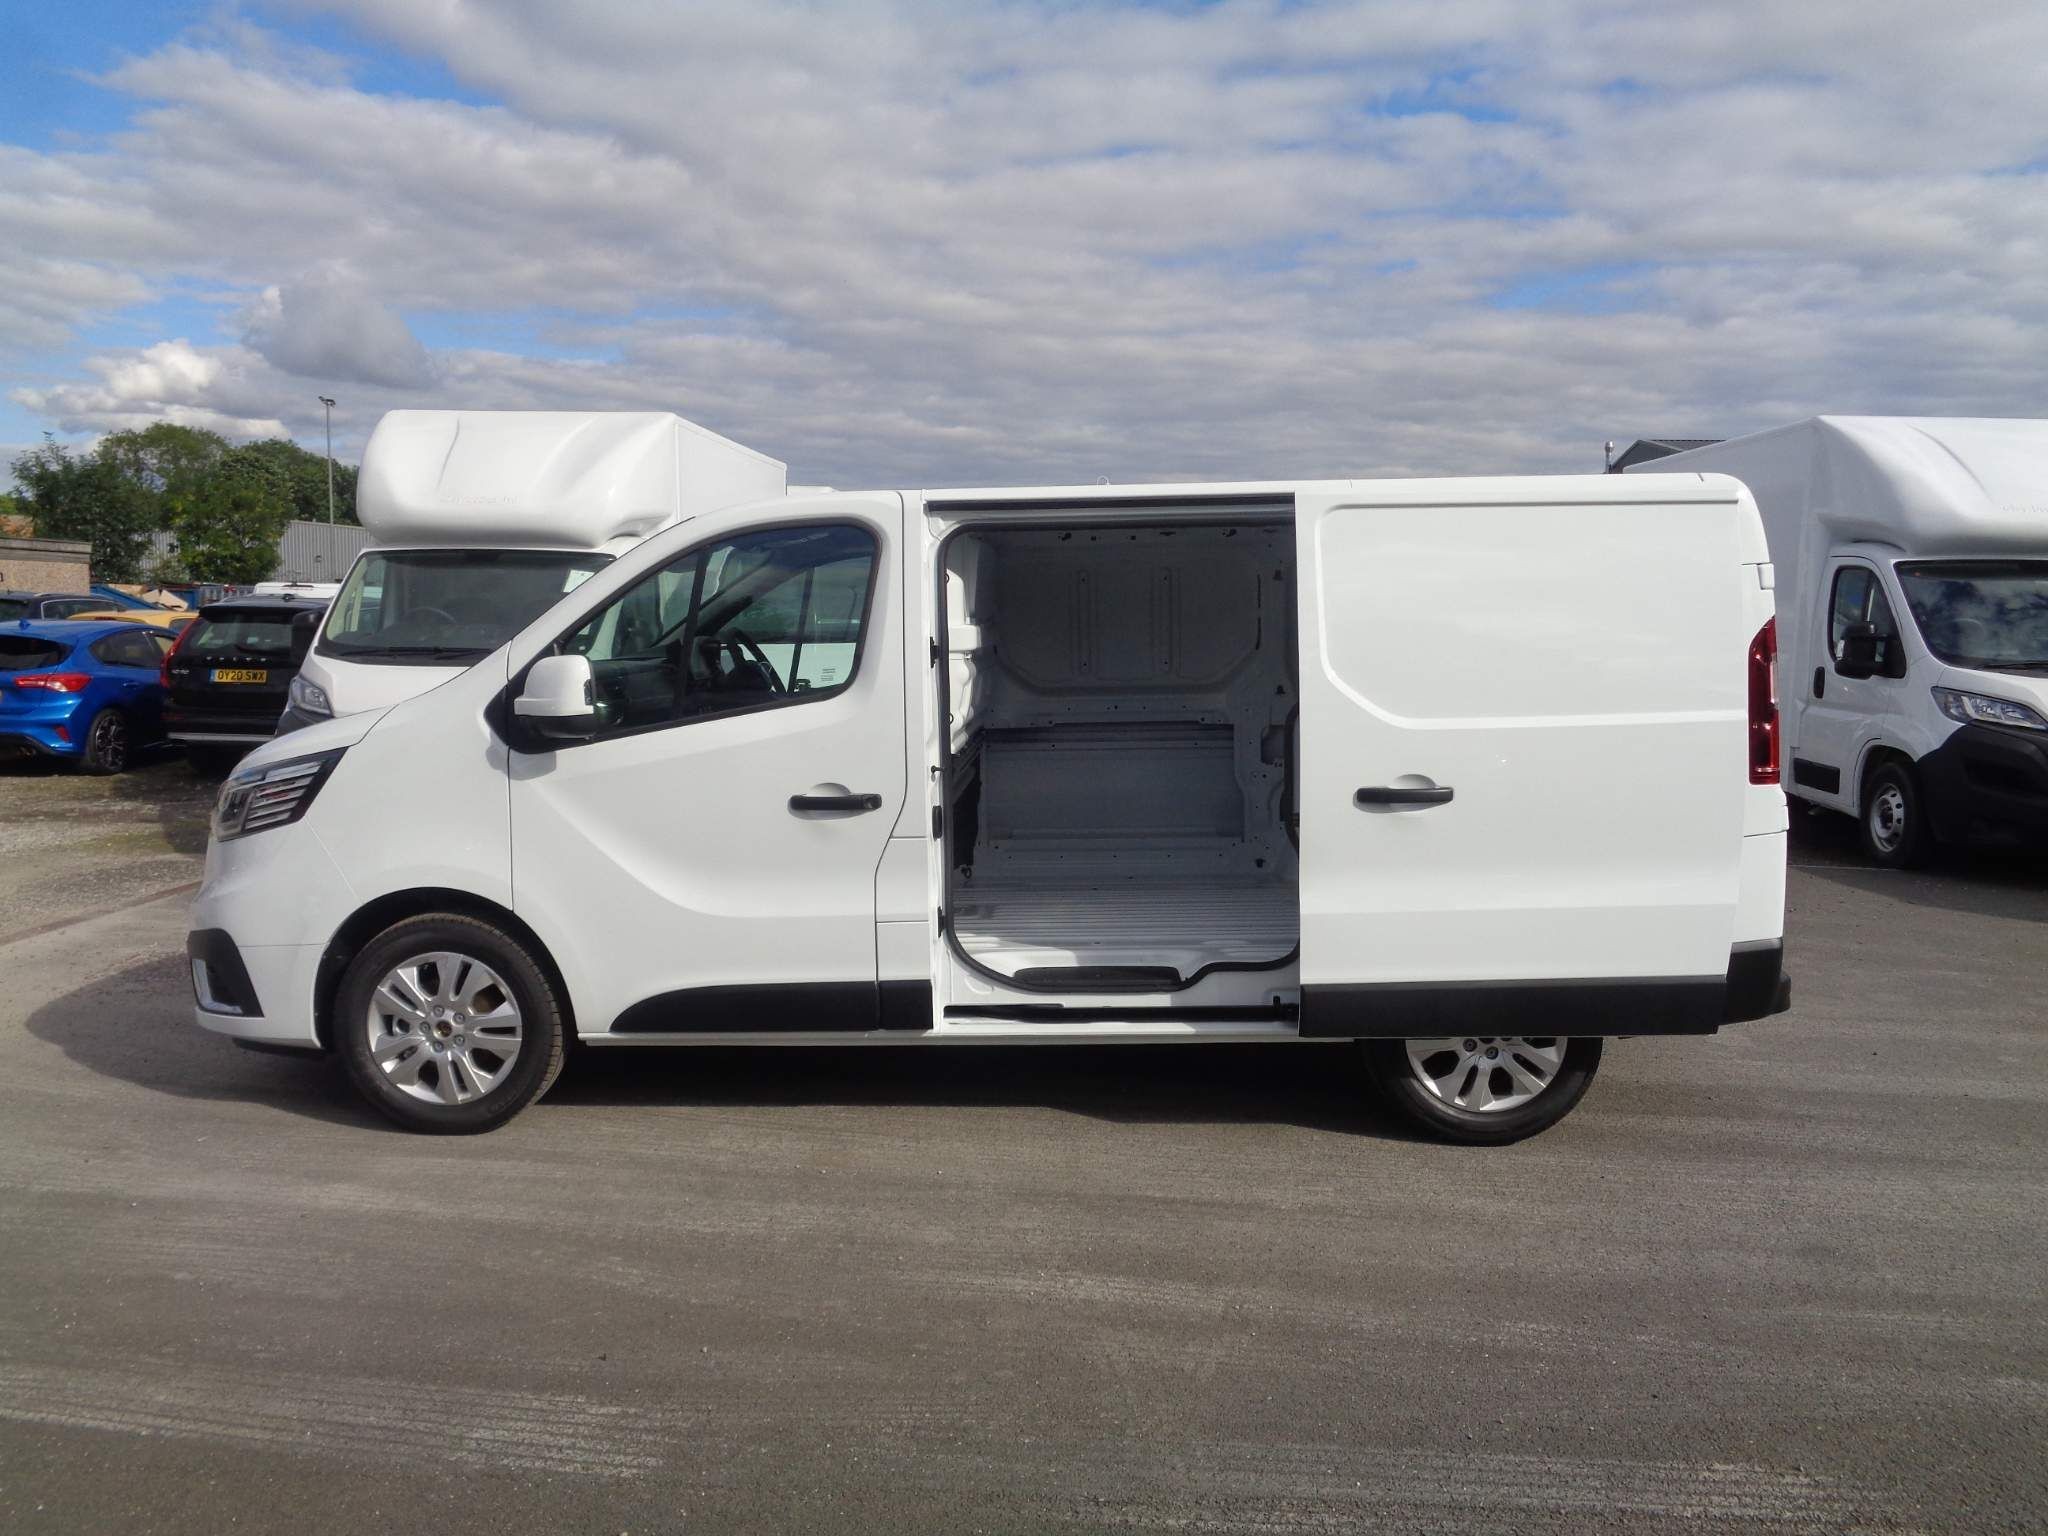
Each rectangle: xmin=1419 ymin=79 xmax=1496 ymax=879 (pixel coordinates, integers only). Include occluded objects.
xmin=29 ymin=954 xmax=1413 ymax=1141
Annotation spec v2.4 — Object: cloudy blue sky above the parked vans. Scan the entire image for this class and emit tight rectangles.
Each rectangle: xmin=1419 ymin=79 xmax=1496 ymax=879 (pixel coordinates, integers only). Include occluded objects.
xmin=0 ymin=0 xmax=2048 ymax=483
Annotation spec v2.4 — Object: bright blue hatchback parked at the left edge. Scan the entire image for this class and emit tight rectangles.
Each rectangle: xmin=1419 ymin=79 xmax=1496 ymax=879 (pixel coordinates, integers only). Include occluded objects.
xmin=0 ymin=618 xmax=172 ymax=774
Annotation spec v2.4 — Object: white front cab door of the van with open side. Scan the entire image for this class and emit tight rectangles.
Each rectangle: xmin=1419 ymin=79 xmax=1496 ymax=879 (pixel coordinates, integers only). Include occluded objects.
xmin=512 ymin=496 xmax=907 ymax=1034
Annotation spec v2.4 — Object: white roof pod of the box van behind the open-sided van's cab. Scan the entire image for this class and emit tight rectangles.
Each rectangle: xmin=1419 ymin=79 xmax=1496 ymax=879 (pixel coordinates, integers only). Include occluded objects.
xmin=356 ymin=410 xmax=788 ymax=549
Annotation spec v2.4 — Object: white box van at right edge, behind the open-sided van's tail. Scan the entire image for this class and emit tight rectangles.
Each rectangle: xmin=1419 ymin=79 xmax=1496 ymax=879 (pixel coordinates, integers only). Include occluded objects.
xmin=1632 ymin=416 xmax=2048 ymax=866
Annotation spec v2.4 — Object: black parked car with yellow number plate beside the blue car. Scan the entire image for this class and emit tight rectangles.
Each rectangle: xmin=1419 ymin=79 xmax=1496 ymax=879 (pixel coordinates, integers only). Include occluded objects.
xmin=164 ymin=596 xmax=328 ymax=764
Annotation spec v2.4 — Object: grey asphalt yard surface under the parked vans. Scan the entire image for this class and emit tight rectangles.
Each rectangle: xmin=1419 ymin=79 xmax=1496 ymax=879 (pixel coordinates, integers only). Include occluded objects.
xmin=0 ymin=782 xmax=2048 ymax=1536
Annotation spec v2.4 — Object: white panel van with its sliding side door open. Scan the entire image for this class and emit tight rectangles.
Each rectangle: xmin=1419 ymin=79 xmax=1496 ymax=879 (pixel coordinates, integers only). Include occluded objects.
xmin=188 ymin=475 xmax=1790 ymax=1143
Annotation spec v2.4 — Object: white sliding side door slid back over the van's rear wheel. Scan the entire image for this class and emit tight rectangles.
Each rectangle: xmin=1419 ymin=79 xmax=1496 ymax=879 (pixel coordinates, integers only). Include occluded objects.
xmin=1296 ymin=475 xmax=1767 ymax=1036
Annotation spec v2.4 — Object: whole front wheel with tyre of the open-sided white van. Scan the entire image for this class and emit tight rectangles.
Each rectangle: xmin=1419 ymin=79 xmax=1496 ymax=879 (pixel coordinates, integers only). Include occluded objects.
xmin=334 ymin=913 xmax=563 ymax=1135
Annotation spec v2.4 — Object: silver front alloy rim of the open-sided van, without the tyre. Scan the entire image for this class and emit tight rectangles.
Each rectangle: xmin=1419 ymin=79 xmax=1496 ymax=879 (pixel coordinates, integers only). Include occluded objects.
xmin=362 ymin=950 xmax=524 ymax=1104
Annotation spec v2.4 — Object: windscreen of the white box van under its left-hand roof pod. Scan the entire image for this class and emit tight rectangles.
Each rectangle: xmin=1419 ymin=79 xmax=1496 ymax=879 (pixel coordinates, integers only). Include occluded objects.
xmin=319 ymin=549 xmax=610 ymax=666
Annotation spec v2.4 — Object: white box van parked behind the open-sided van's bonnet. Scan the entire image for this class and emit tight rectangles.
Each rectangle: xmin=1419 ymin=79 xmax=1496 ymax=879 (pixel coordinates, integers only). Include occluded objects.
xmin=279 ymin=410 xmax=788 ymax=733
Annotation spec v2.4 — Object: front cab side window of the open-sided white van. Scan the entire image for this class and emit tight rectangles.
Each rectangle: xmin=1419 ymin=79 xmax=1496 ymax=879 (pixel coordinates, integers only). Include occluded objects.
xmin=555 ymin=522 xmax=877 ymax=739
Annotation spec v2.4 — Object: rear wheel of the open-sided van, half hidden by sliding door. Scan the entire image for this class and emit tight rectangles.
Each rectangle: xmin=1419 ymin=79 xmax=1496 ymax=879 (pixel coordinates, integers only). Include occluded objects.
xmin=1364 ymin=1034 xmax=1599 ymax=1147
